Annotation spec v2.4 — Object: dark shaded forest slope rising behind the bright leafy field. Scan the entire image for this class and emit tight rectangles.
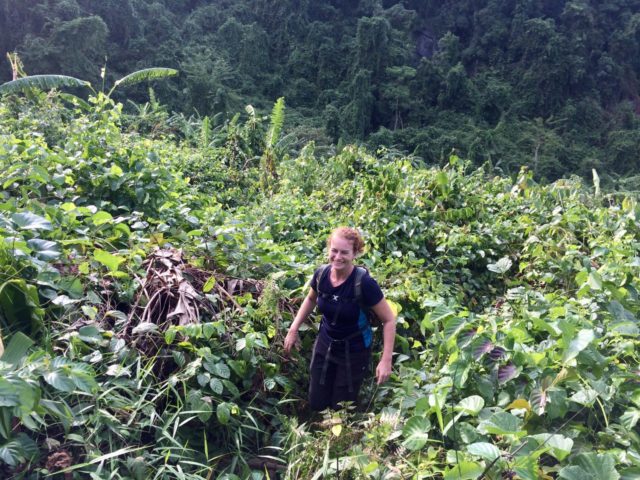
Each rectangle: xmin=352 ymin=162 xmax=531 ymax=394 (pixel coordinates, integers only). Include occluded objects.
xmin=0 ymin=0 xmax=640 ymax=184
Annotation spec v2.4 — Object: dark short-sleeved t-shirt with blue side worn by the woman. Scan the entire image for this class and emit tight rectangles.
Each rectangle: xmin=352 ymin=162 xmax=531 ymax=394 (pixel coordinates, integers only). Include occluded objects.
xmin=311 ymin=267 xmax=384 ymax=351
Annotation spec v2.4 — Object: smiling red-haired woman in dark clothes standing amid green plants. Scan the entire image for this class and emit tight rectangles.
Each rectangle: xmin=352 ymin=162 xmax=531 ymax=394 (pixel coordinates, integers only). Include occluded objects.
xmin=284 ymin=227 xmax=396 ymax=410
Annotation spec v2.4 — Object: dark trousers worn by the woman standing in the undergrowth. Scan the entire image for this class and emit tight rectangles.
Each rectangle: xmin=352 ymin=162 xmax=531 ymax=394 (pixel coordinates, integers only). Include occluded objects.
xmin=309 ymin=342 xmax=371 ymax=411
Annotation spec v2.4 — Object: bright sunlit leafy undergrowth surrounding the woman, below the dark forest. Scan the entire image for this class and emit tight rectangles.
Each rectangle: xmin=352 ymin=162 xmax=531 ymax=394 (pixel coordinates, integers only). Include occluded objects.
xmin=0 ymin=94 xmax=640 ymax=480
